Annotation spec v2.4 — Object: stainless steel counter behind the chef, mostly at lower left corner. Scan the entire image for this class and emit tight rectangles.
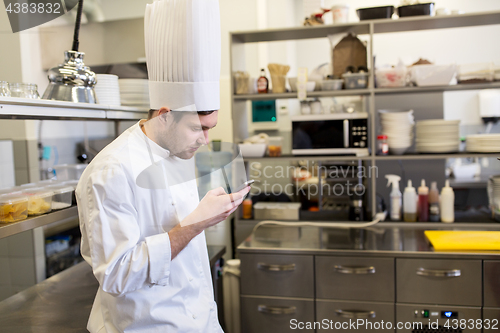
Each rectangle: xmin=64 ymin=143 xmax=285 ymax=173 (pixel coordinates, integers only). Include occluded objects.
xmin=0 ymin=246 xmax=226 ymax=333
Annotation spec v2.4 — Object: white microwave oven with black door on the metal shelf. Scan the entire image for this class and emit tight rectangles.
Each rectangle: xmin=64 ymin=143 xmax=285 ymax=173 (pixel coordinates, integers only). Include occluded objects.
xmin=291 ymin=112 xmax=369 ymax=156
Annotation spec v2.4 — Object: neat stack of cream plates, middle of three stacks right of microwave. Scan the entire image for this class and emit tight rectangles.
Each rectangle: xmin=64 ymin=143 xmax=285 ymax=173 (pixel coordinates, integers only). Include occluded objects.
xmin=416 ymin=119 xmax=460 ymax=153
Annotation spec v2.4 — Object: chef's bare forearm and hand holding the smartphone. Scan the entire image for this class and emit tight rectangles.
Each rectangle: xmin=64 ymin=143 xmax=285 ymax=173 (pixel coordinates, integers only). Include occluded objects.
xmin=168 ymin=186 xmax=250 ymax=259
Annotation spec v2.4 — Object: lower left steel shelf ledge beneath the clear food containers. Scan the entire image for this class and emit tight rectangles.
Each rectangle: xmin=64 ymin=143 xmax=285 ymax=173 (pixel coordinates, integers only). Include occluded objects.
xmin=0 ymin=206 xmax=78 ymax=238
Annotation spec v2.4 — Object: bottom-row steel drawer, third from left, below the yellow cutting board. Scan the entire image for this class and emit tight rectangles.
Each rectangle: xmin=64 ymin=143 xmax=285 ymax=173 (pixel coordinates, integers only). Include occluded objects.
xmin=395 ymin=304 xmax=481 ymax=333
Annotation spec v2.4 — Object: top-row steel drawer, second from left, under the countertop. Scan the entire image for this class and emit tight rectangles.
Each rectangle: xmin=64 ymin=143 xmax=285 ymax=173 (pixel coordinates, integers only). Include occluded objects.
xmin=315 ymin=256 xmax=395 ymax=302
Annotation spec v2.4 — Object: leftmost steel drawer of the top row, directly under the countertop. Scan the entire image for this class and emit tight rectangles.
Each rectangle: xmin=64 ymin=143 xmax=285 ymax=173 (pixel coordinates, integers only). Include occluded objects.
xmin=240 ymin=254 xmax=314 ymax=298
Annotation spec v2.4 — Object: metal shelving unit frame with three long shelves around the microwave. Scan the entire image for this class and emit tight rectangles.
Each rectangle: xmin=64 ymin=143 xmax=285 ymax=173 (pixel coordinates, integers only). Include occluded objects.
xmin=230 ymin=11 xmax=500 ymax=225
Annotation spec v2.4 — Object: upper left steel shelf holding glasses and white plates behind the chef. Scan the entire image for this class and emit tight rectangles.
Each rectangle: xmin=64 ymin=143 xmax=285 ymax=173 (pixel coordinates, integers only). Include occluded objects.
xmin=0 ymin=97 xmax=147 ymax=121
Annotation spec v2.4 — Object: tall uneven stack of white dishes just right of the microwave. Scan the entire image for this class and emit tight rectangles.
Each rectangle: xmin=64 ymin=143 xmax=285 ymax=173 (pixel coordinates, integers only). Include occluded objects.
xmin=379 ymin=110 xmax=415 ymax=155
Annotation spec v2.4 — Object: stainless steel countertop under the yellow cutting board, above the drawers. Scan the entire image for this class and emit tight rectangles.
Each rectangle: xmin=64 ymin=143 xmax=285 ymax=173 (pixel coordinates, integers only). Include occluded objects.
xmin=238 ymin=225 xmax=500 ymax=260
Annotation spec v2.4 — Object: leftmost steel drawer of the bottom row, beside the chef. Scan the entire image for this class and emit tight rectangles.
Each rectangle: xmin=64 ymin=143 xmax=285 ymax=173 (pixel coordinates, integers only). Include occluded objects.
xmin=241 ymin=296 xmax=314 ymax=333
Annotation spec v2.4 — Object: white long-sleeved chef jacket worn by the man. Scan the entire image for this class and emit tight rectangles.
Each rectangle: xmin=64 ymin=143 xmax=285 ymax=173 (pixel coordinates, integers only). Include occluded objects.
xmin=76 ymin=123 xmax=222 ymax=333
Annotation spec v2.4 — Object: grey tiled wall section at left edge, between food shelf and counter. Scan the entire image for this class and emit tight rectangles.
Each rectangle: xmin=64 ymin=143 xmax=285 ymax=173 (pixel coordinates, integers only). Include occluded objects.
xmin=0 ymin=228 xmax=45 ymax=301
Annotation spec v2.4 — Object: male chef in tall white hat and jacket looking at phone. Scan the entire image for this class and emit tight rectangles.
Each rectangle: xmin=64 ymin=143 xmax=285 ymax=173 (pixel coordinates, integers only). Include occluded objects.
xmin=76 ymin=0 xmax=249 ymax=333
